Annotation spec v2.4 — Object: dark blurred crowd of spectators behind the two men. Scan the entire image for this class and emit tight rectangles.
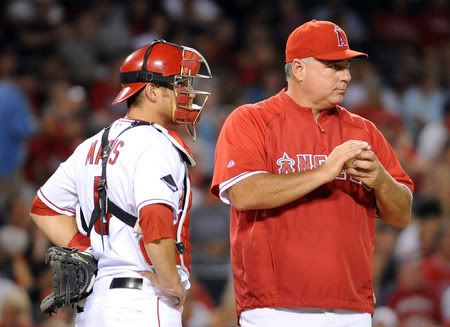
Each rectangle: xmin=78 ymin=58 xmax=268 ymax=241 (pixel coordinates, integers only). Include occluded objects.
xmin=0 ymin=0 xmax=450 ymax=327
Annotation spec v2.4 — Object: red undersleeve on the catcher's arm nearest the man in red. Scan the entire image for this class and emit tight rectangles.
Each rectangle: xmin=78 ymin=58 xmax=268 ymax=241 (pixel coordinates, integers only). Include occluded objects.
xmin=139 ymin=203 xmax=176 ymax=244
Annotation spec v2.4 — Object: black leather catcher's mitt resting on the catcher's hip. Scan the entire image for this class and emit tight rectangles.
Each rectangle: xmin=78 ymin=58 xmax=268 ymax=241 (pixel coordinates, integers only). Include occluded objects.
xmin=41 ymin=246 xmax=97 ymax=314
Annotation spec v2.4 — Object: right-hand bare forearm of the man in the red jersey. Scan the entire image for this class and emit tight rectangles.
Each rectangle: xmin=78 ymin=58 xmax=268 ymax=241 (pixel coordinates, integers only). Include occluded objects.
xmin=375 ymin=173 xmax=412 ymax=227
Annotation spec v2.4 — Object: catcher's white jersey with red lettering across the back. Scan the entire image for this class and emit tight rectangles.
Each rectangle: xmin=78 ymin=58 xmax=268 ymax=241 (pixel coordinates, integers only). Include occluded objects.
xmin=38 ymin=118 xmax=195 ymax=280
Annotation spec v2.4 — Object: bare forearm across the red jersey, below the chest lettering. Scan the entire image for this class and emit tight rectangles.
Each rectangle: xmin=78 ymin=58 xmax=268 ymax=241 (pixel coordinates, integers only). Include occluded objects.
xmin=228 ymin=167 xmax=330 ymax=210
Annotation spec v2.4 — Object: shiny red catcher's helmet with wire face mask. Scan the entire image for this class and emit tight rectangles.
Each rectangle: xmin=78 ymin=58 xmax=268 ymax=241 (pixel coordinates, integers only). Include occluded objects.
xmin=113 ymin=40 xmax=212 ymax=140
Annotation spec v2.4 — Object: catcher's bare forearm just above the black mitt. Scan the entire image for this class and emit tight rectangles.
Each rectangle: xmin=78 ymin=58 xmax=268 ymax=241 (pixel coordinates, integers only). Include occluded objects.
xmin=30 ymin=212 xmax=78 ymax=246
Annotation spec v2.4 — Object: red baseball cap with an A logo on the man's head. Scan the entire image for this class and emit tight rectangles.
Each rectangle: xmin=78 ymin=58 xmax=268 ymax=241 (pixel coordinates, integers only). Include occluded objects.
xmin=286 ymin=19 xmax=368 ymax=62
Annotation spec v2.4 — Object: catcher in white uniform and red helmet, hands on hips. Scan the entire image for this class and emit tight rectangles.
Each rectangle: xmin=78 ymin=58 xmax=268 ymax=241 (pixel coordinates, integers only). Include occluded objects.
xmin=30 ymin=40 xmax=212 ymax=327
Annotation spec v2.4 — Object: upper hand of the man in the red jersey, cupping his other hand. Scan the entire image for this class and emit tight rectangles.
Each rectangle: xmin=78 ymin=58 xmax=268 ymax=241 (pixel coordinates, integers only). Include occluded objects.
xmin=320 ymin=140 xmax=370 ymax=182
